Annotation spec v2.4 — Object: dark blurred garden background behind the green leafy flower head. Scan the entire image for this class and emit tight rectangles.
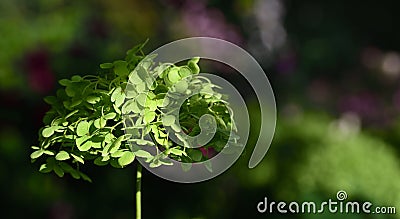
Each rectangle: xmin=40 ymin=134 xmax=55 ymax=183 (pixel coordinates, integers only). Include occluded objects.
xmin=0 ymin=0 xmax=400 ymax=219
